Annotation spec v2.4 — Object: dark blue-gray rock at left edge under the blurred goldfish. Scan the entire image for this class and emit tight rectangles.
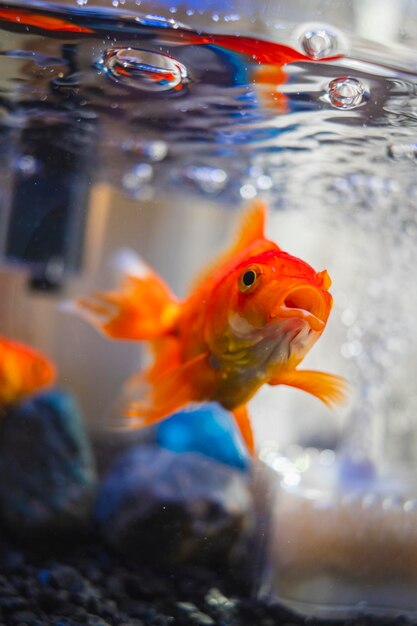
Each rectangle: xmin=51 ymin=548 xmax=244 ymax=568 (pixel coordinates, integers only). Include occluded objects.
xmin=0 ymin=391 xmax=96 ymax=538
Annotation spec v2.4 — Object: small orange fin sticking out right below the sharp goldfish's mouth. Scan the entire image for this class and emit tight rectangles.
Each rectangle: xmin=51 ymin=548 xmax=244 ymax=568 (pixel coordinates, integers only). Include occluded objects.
xmin=268 ymin=369 xmax=348 ymax=407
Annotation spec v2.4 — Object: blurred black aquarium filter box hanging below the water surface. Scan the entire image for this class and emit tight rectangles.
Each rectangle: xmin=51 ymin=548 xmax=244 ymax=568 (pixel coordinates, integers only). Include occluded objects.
xmin=0 ymin=115 xmax=94 ymax=290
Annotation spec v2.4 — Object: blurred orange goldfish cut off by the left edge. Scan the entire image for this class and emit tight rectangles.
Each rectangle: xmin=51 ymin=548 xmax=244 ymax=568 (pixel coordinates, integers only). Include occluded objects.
xmin=0 ymin=337 xmax=55 ymax=410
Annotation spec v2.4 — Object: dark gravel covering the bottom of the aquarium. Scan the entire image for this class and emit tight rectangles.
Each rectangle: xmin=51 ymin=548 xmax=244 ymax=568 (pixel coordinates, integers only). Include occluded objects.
xmin=0 ymin=540 xmax=410 ymax=626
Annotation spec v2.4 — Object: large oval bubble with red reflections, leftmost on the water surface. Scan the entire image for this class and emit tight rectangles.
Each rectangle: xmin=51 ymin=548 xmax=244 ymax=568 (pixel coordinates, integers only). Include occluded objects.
xmin=99 ymin=48 xmax=189 ymax=93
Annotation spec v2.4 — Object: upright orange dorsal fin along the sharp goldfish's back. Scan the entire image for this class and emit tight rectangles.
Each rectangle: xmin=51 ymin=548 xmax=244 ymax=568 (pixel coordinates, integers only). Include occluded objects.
xmin=192 ymin=198 xmax=268 ymax=289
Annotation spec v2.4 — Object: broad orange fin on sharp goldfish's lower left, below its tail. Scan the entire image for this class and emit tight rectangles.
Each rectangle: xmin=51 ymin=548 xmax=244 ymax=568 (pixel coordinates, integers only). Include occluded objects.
xmin=116 ymin=354 xmax=207 ymax=430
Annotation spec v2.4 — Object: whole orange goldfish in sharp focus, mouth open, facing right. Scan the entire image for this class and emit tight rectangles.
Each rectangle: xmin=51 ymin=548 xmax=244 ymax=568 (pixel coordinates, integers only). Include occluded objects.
xmin=74 ymin=200 xmax=346 ymax=454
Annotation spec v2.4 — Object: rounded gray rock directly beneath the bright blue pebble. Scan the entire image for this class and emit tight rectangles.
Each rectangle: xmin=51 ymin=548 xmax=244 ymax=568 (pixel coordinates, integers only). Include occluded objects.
xmin=97 ymin=445 xmax=253 ymax=565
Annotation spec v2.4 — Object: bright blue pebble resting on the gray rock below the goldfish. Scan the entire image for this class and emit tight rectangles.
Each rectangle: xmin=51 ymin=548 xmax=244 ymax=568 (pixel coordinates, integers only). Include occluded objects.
xmin=156 ymin=402 xmax=250 ymax=470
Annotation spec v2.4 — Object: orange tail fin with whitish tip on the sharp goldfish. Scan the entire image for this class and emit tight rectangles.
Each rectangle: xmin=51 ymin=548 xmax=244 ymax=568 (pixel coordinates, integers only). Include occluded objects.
xmin=70 ymin=246 xmax=179 ymax=340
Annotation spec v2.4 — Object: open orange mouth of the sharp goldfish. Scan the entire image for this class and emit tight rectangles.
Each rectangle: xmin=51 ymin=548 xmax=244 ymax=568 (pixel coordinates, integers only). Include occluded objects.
xmin=274 ymin=285 xmax=328 ymax=331
